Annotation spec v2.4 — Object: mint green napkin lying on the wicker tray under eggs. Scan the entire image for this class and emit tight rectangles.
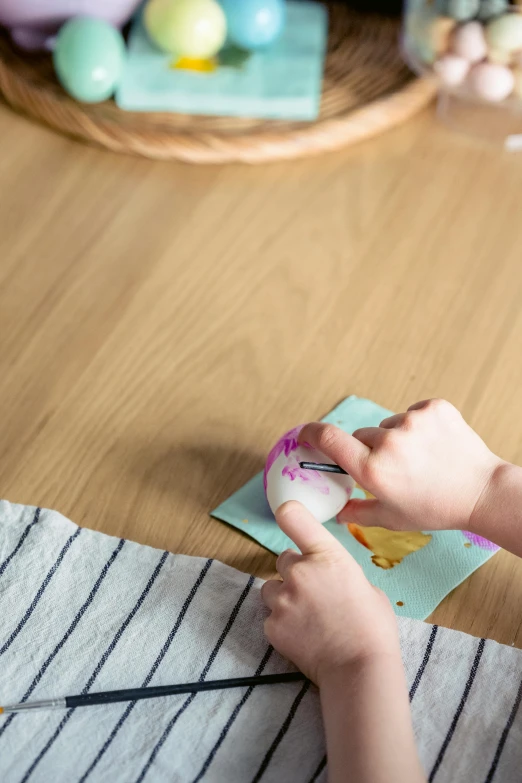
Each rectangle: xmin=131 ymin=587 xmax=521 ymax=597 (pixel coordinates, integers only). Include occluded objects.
xmin=116 ymin=0 xmax=328 ymax=120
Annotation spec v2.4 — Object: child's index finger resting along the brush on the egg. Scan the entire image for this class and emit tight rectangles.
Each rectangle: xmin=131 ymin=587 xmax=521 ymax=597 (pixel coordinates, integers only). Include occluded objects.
xmin=299 ymin=422 xmax=370 ymax=481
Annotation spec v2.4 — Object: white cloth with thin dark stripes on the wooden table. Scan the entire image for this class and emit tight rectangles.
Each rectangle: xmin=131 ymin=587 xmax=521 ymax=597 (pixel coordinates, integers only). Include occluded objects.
xmin=0 ymin=502 xmax=522 ymax=783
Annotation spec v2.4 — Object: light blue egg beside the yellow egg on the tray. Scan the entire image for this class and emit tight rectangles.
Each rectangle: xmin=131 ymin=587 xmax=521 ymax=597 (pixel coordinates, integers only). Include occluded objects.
xmin=221 ymin=0 xmax=286 ymax=49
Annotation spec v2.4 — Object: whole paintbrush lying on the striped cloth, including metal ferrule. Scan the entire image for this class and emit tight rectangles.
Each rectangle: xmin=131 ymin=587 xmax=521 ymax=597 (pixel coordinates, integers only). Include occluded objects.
xmin=0 ymin=672 xmax=306 ymax=715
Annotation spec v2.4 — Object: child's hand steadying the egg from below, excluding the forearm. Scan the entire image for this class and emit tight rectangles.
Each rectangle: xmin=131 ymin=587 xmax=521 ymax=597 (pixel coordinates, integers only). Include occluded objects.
xmin=261 ymin=501 xmax=398 ymax=685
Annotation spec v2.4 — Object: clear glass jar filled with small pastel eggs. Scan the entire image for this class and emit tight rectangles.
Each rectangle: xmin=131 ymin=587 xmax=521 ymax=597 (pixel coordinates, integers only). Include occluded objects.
xmin=403 ymin=0 xmax=522 ymax=149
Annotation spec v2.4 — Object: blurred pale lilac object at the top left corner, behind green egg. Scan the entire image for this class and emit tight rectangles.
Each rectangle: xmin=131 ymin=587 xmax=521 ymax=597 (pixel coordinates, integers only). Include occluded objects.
xmin=0 ymin=0 xmax=140 ymax=49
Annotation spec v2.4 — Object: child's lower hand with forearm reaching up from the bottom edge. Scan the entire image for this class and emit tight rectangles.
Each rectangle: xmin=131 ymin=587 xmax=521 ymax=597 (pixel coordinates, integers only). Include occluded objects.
xmin=262 ymin=502 xmax=426 ymax=783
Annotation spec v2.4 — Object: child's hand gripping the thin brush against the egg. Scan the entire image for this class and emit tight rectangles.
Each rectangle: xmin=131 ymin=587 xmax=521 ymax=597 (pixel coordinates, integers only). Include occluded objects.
xmin=300 ymin=400 xmax=504 ymax=530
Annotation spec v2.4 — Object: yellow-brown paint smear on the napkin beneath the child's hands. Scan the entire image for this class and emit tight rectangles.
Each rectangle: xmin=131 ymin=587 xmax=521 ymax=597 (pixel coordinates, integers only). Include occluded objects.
xmin=348 ymin=522 xmax=432 ymax=569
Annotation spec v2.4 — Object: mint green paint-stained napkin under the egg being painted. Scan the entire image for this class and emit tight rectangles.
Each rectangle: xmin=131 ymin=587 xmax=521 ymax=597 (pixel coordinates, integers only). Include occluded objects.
xmin=212 ymin=397 xmax=498 ymax=620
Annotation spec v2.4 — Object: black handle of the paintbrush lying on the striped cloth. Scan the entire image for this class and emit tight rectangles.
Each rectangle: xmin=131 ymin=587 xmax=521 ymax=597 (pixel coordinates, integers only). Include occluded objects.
xmin=65 ymin=672 xmax=306 ymax=708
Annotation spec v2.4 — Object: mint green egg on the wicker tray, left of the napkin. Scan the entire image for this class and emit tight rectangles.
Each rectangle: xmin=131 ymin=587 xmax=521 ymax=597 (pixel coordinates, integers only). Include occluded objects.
xmin=54 ymin=17 xmax=126 ymax=103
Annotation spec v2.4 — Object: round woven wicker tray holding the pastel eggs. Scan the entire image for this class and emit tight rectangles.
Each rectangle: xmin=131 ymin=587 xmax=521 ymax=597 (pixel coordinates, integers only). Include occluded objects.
xmin=0 ymin=4 xmax=435 ymax=163
